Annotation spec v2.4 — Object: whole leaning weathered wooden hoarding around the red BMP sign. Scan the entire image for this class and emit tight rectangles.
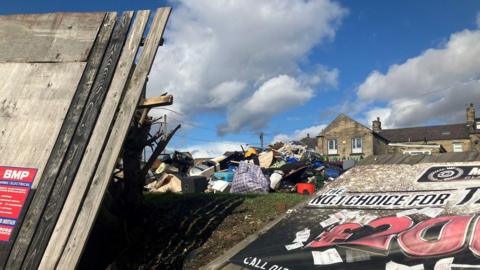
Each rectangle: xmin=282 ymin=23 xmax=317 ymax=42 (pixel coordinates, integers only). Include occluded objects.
xmin=0 ymin=8 xmax=174 ymax=269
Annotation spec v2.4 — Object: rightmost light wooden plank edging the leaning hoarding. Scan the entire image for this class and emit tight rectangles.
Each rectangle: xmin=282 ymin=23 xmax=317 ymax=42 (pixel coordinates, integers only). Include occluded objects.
xmin=57 ymin=8 xmax=171 ymax=269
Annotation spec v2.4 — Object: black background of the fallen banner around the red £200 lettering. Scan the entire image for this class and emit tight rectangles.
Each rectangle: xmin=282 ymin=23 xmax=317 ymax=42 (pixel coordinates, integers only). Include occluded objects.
xmin=230 ymin=208 xmax=480 ymax=270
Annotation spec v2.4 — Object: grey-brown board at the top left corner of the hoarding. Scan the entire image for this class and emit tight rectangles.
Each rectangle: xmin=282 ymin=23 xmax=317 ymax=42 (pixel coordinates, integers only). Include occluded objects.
xmin=0 ymin=12 xmax=105 ymax=62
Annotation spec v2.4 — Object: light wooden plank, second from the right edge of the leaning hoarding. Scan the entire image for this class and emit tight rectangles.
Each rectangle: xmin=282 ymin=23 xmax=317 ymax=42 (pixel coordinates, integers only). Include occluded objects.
xmin=37 ymin=10 xmax=150 ymax=269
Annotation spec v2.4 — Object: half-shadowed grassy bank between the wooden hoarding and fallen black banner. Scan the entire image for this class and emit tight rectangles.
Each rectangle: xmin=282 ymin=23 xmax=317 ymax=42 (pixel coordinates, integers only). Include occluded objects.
xmin=124 ymin=193 xmax=306 ymax=269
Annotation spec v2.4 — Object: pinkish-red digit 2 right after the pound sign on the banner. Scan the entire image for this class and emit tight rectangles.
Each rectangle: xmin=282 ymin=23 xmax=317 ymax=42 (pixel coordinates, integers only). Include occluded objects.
xmin=346 ymin=216 xmax=413 ymax=251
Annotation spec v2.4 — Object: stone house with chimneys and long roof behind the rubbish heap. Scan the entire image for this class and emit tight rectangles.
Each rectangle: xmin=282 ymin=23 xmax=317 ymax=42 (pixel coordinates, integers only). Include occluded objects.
xmin=316 ymin=104 xmax=480 ymax=159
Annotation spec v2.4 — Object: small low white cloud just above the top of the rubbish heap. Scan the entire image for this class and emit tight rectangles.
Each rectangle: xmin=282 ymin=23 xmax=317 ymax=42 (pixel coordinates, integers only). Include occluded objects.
xmin=178 ymin=141 xmax=245 ymax=158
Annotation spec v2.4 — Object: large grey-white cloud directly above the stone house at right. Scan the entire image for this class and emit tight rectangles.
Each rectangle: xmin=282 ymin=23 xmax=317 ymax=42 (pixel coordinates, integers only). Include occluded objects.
xmin=357 ymin=30 xmax=480 ymax=127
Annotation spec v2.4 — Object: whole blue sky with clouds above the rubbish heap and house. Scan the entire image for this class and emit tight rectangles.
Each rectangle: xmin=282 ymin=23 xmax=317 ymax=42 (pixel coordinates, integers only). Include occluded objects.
xmin=0 ymin=0 xmax=480 ymax=157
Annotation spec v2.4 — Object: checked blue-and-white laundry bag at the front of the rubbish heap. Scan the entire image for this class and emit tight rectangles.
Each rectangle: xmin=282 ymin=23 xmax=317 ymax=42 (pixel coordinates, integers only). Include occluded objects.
xmin=230 ymin=161 xmax=269 ymax=193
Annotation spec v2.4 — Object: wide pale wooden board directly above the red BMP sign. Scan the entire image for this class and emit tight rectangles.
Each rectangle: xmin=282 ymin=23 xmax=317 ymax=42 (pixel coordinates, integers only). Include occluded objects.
xmin=0 ymin=63 xmax=85 ymax=269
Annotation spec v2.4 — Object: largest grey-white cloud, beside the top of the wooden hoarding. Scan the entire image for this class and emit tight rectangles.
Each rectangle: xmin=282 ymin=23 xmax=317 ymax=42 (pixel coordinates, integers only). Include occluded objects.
xmin=148 ymin=0 xmax=347 ymax=132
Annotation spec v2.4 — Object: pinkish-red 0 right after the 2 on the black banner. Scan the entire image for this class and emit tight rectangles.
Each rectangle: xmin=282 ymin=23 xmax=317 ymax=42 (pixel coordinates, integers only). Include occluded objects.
xmin=398 ymin=216 xmax=473 ymax=257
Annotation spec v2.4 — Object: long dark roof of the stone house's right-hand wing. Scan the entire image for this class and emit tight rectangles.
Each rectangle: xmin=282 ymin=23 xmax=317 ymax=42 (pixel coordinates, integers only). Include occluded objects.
xmin=378 ymin=123 xmax=469 ymax=143
